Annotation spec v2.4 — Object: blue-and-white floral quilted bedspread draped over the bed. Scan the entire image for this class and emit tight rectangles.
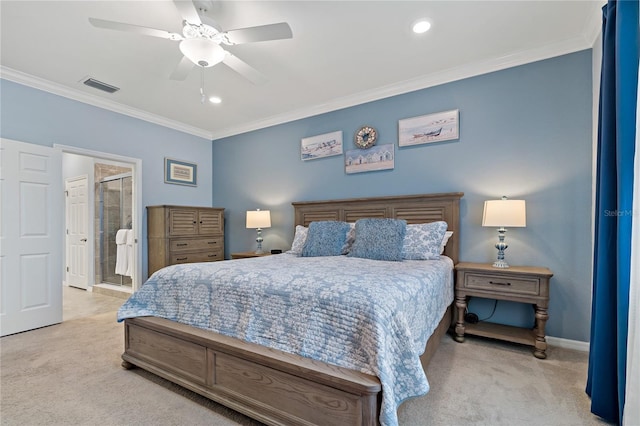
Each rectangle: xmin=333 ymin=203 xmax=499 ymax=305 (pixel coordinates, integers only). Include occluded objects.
xmin=118 ymin=253 xmax=453 ymax=425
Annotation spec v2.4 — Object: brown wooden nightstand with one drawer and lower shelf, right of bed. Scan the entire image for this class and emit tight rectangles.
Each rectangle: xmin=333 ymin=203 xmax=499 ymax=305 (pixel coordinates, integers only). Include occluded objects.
xmin=455 ymin=262 xmax=553 ymax=359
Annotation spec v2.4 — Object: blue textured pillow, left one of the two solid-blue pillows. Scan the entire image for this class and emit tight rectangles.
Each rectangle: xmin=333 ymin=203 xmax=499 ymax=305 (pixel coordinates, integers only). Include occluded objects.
xmin=302 ymin=221 xmax=349 ymax=257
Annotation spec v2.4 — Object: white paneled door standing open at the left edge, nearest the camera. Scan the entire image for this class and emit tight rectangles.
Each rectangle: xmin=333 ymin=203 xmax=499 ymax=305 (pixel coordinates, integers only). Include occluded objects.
xmin=0 ymin=139 xmax=63 ymax=336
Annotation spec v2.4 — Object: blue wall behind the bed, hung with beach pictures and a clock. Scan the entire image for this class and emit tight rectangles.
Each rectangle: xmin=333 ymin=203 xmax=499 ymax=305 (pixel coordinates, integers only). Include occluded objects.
xmin=213 ymin=50 xmax=592 ymax=341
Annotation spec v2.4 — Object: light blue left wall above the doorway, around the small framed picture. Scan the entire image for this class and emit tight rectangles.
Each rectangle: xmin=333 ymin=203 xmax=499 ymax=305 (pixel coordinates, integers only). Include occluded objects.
xmin=0 ymin=80 xmax=212 ymax=278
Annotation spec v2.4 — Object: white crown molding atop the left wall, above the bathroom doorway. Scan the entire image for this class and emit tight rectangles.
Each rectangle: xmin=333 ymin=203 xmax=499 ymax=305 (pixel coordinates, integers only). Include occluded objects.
xmin=0 ymin=65 xmax=212 ymax=140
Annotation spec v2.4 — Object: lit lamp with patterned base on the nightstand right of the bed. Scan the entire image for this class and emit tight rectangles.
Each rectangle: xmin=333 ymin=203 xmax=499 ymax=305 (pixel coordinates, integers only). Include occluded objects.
xmin=482 ymin=197 xmax=527 ymax=268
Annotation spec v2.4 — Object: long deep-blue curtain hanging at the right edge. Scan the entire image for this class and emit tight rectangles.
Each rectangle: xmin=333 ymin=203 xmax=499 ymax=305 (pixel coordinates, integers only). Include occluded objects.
xmin=586 ymin=0 xmax=639 ymax=423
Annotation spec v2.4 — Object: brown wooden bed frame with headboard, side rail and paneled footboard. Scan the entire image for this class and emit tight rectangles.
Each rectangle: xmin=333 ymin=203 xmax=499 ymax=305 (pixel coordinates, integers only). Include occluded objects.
xmin=122 ymin=193 xmax=463 ymax=426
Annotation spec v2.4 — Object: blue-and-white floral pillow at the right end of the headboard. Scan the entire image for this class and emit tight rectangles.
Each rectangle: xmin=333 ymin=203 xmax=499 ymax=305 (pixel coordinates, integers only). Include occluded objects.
xmin=402 ymin=221 xmax=447 ymax=260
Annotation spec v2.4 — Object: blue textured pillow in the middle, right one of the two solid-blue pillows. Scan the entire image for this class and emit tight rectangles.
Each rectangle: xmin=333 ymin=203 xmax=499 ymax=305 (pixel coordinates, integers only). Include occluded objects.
xmin=348 ymin=219 xmax=407 ymax=261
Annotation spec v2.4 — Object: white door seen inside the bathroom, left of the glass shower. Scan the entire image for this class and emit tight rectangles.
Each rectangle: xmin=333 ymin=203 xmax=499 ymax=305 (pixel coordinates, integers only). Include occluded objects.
xmin=64 ymin=176 xmax=89 ymax=290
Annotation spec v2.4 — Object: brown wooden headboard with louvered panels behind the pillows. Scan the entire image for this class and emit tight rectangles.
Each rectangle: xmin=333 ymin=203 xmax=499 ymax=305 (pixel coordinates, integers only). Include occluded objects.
xmin=291 ymin=192 xmax=464 ymax=264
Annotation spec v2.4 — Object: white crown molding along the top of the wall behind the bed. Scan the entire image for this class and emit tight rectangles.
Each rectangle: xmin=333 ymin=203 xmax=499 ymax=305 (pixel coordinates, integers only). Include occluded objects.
xmin=212 ymin=36 xmax=593 ymax=140
